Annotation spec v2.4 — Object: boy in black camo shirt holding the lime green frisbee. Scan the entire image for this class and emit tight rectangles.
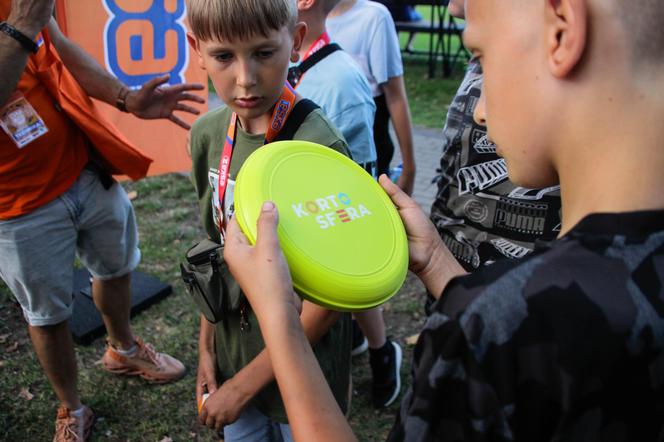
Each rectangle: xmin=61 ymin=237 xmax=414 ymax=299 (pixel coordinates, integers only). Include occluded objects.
xmin=226 ymin=0 xmax=664 ymax=442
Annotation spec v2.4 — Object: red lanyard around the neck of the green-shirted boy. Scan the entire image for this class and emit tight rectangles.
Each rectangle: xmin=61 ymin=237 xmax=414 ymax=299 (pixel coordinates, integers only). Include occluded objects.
xmin=218 ymin=82 xmax=296 ymax=238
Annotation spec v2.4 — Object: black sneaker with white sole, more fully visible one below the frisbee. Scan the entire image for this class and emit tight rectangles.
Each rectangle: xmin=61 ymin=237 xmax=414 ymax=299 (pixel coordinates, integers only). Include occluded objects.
xmin=369 ymin=339 xmax=401 ymax=408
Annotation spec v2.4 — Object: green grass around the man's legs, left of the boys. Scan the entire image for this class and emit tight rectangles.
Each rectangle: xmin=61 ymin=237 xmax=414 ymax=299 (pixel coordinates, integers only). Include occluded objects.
xmin=0 ymin=174 xmax=214 ymax=441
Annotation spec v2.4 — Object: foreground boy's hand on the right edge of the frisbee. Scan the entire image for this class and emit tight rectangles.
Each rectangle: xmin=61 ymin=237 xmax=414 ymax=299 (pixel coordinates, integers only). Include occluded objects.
xmin=379 ymin=175 xmax=466 ymax=297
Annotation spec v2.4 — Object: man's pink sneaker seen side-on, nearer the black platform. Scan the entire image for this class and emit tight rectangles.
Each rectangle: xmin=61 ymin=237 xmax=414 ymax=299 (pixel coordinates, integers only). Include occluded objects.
xmin=101 ymin=338 xmax=185 ymax=384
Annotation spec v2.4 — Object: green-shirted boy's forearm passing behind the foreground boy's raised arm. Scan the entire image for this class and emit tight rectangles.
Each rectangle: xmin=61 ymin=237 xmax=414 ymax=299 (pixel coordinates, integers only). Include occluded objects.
xmin=232 ymin=301 xmax=340 ymax=399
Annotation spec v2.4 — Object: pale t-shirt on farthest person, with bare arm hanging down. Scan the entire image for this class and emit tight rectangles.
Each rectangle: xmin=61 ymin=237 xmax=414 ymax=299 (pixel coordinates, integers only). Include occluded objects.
xmin=326 ymin=0 xmax=403 ymax=97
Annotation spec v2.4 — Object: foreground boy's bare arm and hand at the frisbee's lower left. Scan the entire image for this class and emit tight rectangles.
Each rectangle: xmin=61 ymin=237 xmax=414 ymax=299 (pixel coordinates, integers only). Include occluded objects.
xmin=219 ymin=206 xmax=354 ymax=441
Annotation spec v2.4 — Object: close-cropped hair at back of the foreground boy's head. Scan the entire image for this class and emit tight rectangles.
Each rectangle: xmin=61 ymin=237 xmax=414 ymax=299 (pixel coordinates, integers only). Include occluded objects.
xmin=615 ymin=0 xmax=664 ymax=65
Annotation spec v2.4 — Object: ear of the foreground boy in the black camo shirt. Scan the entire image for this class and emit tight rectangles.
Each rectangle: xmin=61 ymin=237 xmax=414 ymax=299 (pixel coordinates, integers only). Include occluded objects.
xmin=546 ymin=0 xmax=588 ymax=78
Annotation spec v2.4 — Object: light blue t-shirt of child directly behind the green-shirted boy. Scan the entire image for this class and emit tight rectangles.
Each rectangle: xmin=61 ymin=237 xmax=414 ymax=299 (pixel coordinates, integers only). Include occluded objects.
xmin=297 ymin=51 xmax=376 ymax=163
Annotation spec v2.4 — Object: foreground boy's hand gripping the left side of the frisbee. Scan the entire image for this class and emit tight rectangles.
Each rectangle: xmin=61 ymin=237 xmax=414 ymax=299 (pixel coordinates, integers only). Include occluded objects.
xmin=224 ymin=202 xmax=302 ymax=319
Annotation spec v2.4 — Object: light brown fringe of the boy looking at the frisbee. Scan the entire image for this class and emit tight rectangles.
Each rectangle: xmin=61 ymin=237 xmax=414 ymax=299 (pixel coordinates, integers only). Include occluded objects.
xmin=187 ymin=0 xmax=297 ymax=41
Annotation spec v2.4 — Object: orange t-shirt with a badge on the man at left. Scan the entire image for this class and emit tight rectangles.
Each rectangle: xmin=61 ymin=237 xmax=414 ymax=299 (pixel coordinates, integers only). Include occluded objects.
xmin=0 ymin=0 xmax=152 ymax=219
